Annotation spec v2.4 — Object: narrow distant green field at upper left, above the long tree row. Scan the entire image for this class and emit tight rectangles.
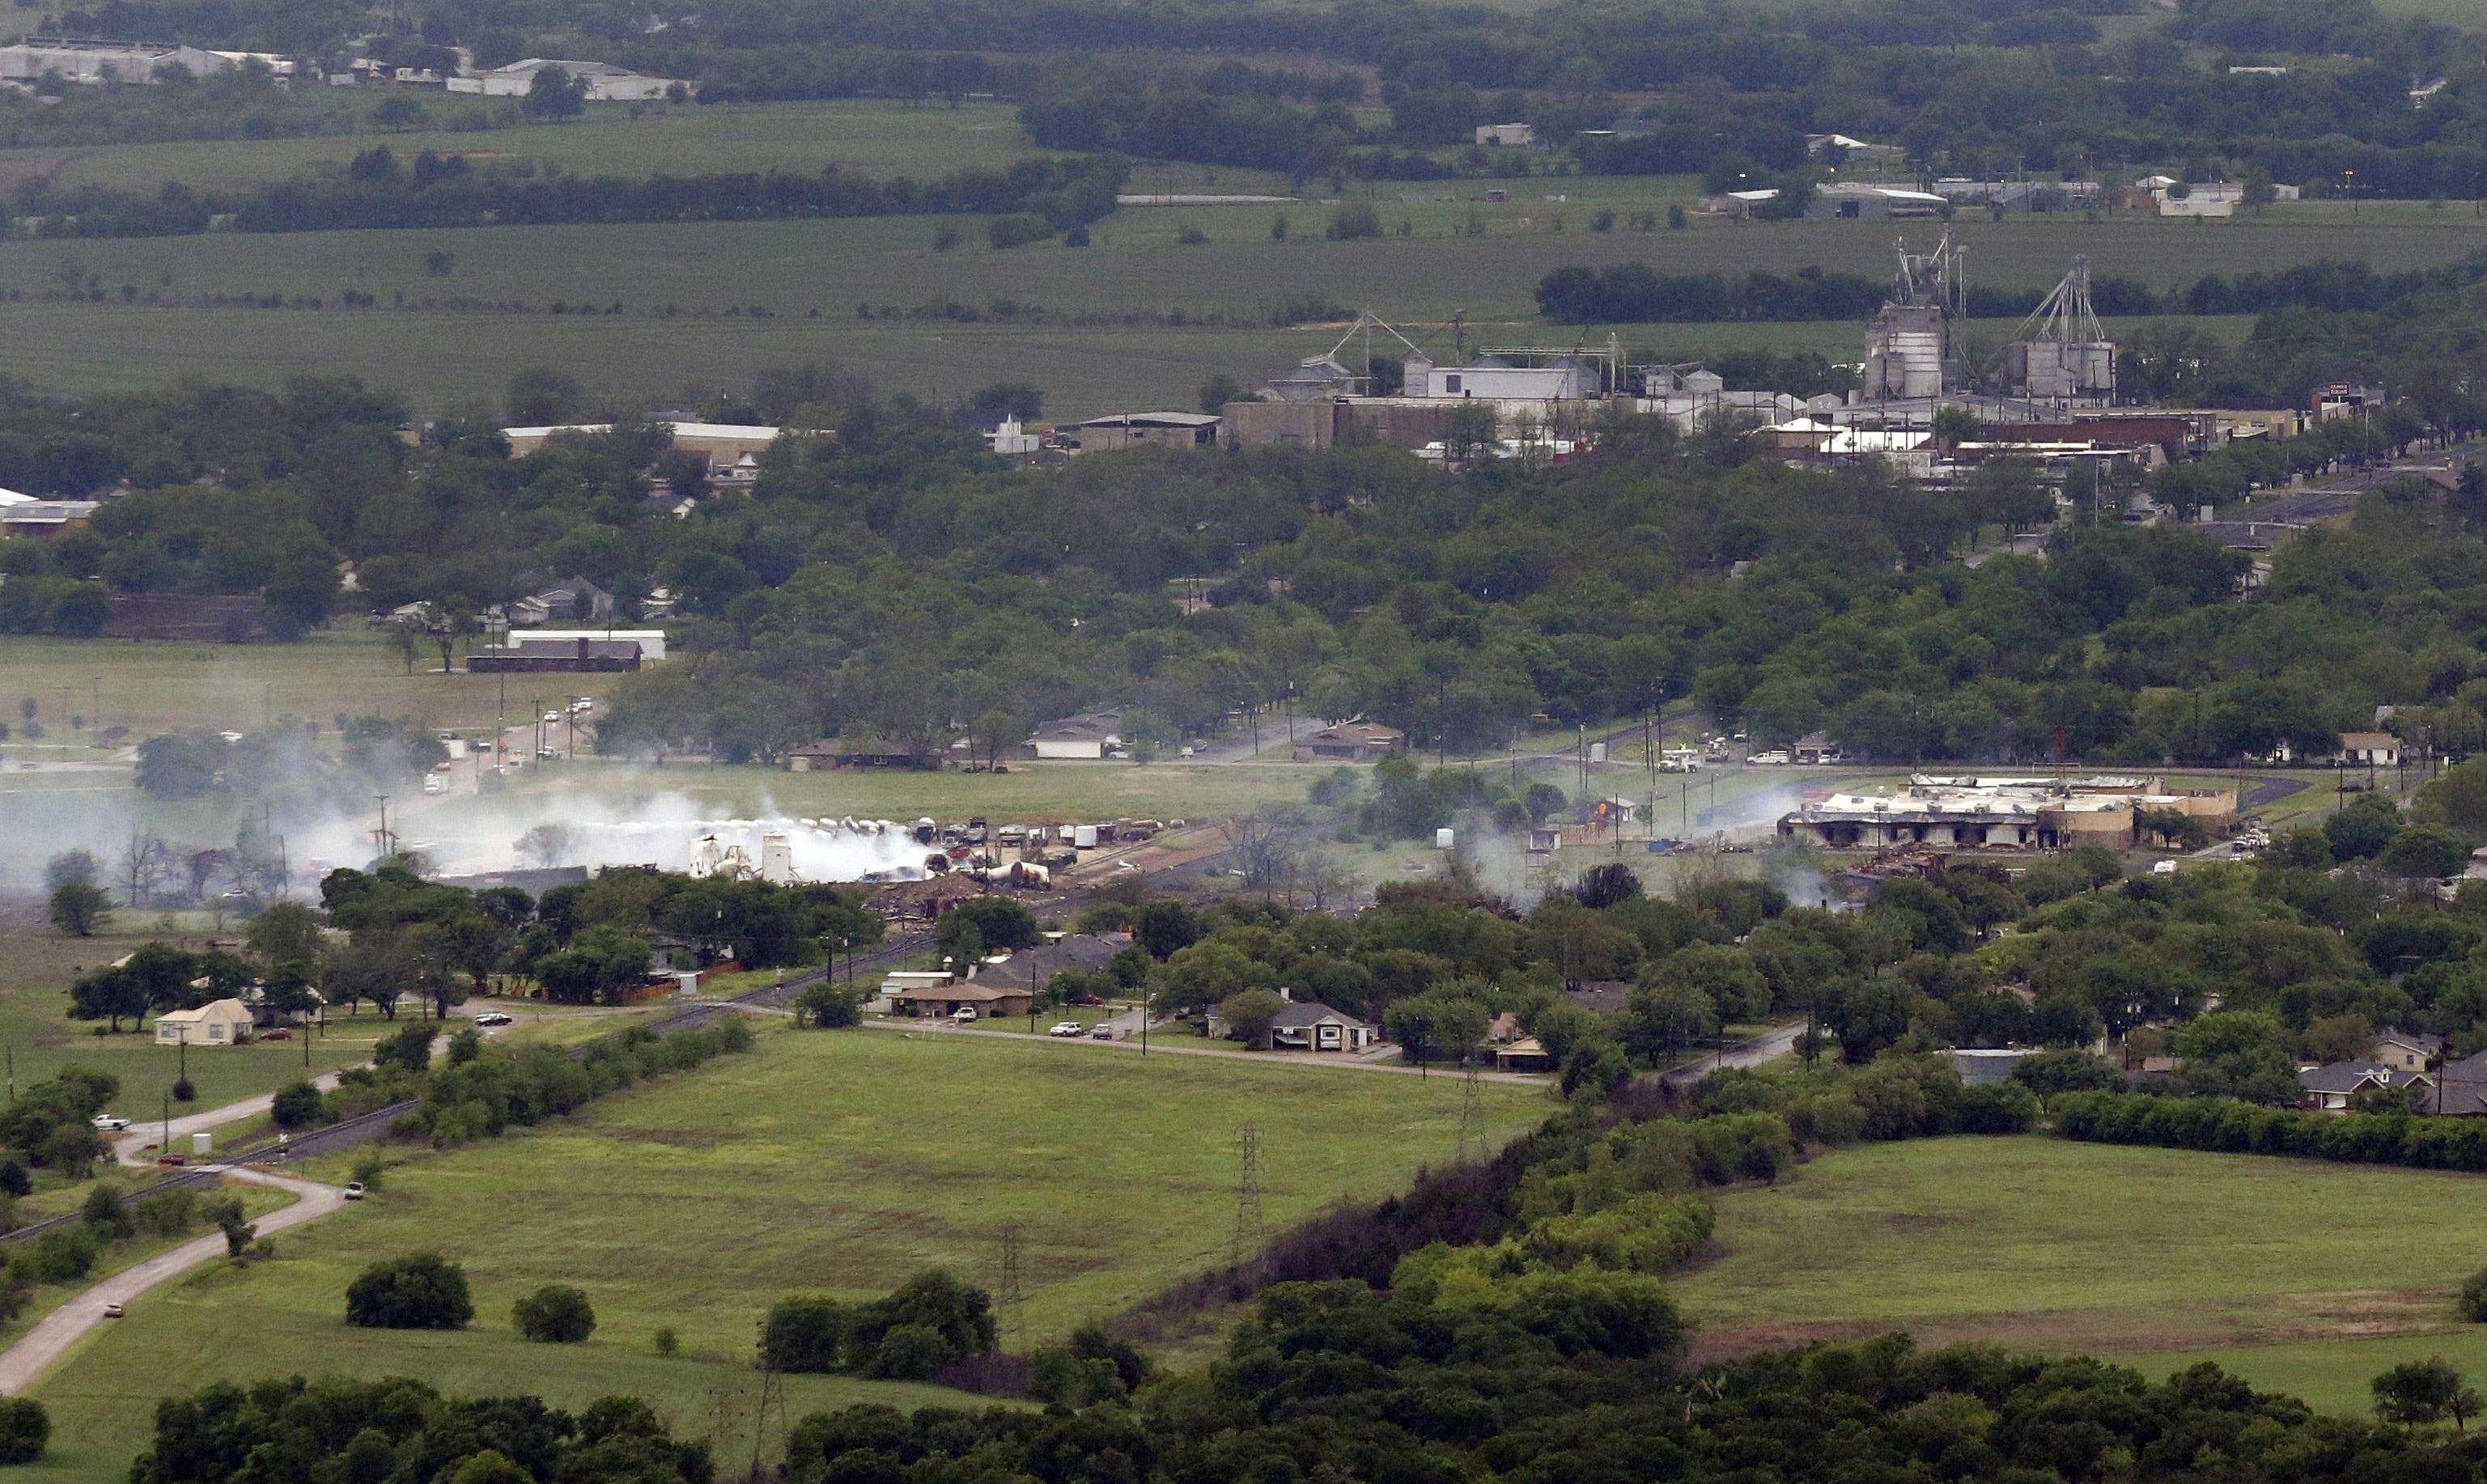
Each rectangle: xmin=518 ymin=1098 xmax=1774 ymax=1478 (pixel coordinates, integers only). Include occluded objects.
xmin=0 ymin=95 xmax=1040 ymax=192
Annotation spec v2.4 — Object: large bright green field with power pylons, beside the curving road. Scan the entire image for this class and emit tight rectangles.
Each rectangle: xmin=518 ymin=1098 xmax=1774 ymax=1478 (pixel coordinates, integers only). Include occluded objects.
xmin=30 ymin=1032 xmax=1547 ymax=1479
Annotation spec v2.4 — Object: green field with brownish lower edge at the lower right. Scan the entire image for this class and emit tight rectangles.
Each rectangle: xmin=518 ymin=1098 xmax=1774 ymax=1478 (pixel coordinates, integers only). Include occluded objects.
xmin=1676 ymin=1138 xmax=2487 ymax=1375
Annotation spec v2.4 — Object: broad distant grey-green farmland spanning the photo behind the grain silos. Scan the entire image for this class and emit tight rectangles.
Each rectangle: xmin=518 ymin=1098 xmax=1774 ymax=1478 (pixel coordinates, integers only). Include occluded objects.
xmin=0 ymin=196 xmax=2457 ymax=415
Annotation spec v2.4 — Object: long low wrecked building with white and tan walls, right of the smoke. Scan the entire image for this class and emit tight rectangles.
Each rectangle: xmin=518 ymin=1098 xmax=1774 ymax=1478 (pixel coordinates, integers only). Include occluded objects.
xmin=1778 ymin=773 xmax=2236 ymax=850
